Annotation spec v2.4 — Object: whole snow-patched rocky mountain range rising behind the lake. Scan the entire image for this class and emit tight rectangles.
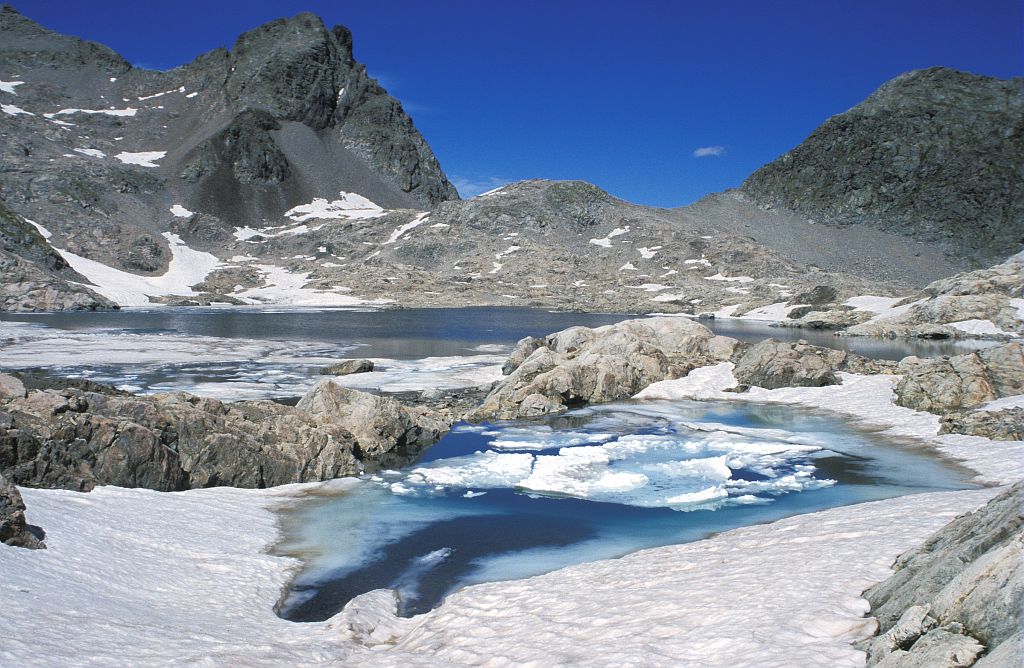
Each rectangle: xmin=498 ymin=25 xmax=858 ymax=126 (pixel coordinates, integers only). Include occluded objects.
xmin=0 ymin=8 xmax=1020 ymax=317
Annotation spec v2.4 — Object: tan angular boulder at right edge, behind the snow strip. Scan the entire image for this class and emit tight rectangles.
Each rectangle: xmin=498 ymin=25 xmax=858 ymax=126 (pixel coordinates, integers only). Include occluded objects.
xmin=895 ymin=342 xmax=1024 ymax=414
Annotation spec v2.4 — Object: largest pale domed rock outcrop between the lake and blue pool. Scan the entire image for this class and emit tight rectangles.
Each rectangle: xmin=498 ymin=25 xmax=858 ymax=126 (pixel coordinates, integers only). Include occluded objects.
xmin=470 ymin=318 xmax=737 ymax=420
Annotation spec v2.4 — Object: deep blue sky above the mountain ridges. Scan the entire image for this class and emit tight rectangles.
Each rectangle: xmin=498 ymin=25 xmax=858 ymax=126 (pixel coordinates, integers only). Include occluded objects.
xmin=10 ymin=0 xmax=1024 ymax=206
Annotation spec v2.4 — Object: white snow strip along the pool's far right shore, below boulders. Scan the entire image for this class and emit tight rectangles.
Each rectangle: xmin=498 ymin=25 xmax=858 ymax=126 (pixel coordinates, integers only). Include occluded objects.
xmin=637 ymin=362 xmax=1024 ymax=485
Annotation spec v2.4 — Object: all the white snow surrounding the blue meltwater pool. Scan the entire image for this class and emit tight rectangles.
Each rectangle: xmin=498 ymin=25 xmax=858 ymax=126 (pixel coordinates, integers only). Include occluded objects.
xmin=0 ymin=365 xmax=1024 ymax=666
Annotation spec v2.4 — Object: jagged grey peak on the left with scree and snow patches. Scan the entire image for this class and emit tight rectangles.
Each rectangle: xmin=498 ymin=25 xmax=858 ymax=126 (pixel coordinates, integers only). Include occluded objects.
xmin=0 ymin=6 xmax=458 ymax=275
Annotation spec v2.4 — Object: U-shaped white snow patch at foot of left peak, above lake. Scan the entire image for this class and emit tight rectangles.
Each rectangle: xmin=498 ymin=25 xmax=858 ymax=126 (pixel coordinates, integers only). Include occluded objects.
xmin=48 ymin=232 xmax=220 ymax=306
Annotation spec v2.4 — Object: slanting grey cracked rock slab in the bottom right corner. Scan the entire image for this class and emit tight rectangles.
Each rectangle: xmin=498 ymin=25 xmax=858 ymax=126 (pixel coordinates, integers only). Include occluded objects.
xmin=864 ymin=483 xmax=1024 ymax=668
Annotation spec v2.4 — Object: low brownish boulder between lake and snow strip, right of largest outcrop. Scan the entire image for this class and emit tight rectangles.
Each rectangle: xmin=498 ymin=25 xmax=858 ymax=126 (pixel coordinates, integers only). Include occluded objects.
xmin=733 ymin=339 xmax=895 ymax=389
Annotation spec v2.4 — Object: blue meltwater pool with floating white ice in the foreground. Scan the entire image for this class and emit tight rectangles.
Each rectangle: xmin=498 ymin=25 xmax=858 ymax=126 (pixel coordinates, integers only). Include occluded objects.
xmin=280 ymin=402 xmax=970 ymax=621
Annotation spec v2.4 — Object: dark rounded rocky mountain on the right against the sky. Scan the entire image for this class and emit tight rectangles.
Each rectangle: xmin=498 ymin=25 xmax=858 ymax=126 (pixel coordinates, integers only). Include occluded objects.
xmin=742 ymin=68 xmax=1024 ymax=264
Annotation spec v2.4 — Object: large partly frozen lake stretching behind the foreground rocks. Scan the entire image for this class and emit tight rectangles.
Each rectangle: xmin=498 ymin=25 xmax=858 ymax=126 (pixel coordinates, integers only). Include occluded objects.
xmin=0 ymin=307 xmax=984 ymax=401
